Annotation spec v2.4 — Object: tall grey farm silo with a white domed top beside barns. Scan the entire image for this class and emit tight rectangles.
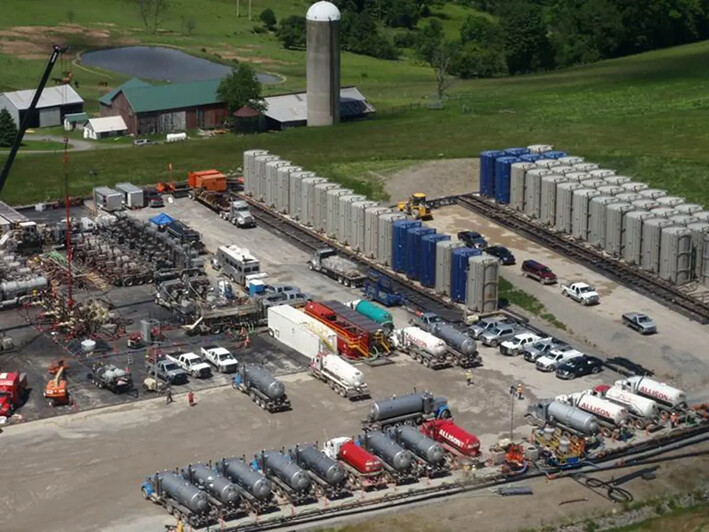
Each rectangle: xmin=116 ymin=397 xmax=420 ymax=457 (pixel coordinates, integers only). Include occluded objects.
xmin=305 ymin=2 xmax=340 ymax=126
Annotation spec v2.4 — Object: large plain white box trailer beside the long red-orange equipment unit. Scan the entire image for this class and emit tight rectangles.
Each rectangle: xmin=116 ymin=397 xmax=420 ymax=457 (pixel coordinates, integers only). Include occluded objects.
xmin=268 ymin=305 xmax=337 ymax=360
